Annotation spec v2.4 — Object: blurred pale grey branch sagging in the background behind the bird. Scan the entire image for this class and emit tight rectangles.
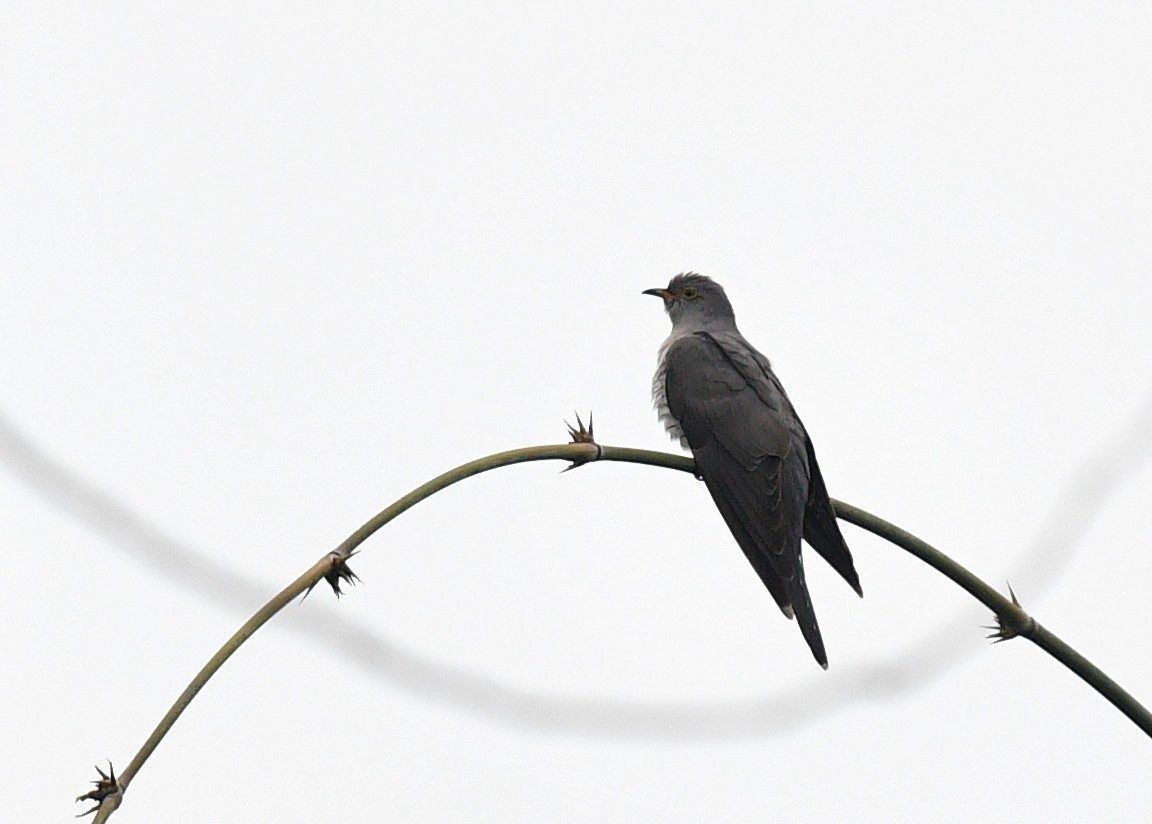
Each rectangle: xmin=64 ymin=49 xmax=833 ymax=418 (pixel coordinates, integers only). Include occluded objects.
xmin=9 ymin=396 xmax=1152 ymax=739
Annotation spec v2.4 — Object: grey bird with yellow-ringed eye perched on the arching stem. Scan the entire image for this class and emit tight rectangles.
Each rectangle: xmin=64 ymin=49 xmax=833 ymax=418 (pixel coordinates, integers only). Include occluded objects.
xmin=644 ymin=272 xmax=864 ymax=670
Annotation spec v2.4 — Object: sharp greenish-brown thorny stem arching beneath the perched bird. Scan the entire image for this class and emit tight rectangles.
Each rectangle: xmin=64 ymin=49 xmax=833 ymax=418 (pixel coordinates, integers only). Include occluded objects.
xmin=93 ymin=442 xmax=1152 ymax=824
